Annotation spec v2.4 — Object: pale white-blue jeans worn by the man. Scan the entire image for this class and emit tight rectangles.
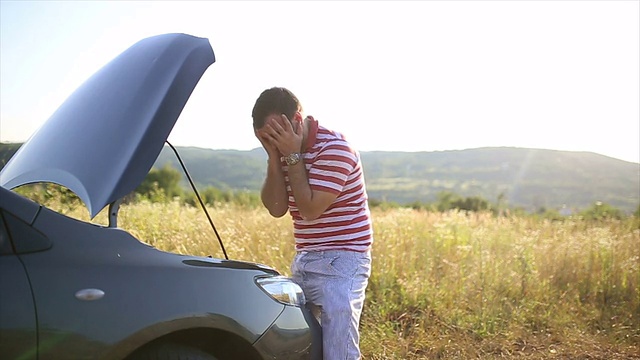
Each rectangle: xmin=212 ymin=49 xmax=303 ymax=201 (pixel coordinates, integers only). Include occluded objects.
xmin=291 ymin=250 xmax=371 ymax=360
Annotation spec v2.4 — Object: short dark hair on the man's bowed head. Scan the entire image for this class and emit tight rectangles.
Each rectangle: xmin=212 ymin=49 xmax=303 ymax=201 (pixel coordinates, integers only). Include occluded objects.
xmin=251 ymin=87 xmax=302 ymax=129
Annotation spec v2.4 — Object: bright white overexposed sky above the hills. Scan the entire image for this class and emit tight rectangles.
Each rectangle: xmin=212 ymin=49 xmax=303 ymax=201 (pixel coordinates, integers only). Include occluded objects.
xmin=0 ymin=0 xmax=640 ymax=163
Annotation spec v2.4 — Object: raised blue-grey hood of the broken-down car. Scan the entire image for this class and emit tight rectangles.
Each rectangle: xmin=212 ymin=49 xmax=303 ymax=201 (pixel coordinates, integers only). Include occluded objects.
xmin=0 ymin=34 xmax=215 ymax=218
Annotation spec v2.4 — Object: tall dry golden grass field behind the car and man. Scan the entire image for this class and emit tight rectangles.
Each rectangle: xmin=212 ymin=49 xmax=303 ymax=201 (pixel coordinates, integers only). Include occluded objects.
xmin=51 ymin=198 xmax=640 ymax=360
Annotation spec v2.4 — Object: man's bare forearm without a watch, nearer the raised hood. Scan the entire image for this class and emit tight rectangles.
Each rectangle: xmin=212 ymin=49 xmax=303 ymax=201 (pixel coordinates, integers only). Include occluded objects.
xmin=260 ymin=157 xmax=289 ymax=217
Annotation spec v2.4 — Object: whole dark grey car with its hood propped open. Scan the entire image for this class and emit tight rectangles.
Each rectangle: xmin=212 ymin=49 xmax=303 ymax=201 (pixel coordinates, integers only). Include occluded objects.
xmin=0 ymin=33 xmax=322 ymax=360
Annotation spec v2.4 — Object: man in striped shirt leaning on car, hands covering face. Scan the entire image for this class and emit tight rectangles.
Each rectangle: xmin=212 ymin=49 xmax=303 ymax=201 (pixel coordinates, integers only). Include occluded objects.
xmin=252 ymin=87 xmax=373 ymax=360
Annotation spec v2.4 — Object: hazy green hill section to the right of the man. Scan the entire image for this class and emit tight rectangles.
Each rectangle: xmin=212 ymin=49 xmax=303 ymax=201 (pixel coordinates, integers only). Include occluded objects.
xmin=362 ymin=148 xmax=640 ymax=211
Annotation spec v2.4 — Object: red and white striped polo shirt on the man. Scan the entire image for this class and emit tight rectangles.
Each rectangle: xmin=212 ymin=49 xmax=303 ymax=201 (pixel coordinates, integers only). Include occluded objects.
xmin=283 ymin=116 xmax=373 ymax=251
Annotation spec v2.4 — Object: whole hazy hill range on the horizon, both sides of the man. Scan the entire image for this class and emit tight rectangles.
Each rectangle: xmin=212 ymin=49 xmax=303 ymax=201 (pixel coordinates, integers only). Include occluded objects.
xmin=0 ymin=144 xmax=640 ymax=212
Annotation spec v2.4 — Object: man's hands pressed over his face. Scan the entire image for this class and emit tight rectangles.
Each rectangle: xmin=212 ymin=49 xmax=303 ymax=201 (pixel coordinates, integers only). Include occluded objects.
xmin=254 ymin=112 xmax=303 ymax=157
